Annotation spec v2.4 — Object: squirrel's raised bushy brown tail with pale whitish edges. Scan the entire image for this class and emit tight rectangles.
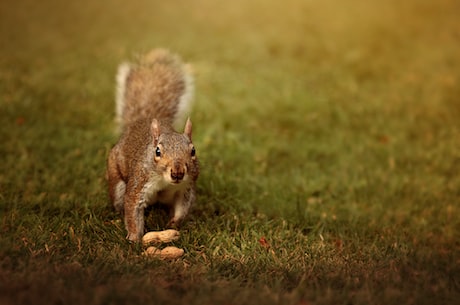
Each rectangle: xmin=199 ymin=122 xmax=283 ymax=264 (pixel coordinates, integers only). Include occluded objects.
xmin=116 ymin=49 xmax=194 ymax=129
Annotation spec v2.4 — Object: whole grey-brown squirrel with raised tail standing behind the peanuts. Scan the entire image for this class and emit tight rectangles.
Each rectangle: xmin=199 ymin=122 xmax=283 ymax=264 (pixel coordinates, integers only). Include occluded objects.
xmin=107 ymin=49 xmax=199 ymax=241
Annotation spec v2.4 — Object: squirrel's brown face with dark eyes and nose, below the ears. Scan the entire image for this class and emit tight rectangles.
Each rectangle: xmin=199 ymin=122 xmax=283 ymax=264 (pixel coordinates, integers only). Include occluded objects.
xmin=153 ymin=133 xmax=198 ymax=184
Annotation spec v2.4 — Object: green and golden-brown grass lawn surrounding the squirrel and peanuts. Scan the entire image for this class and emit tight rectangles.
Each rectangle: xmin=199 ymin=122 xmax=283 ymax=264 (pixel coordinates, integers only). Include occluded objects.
xmin=0 ymin=0 xmax=460 ymax=305
